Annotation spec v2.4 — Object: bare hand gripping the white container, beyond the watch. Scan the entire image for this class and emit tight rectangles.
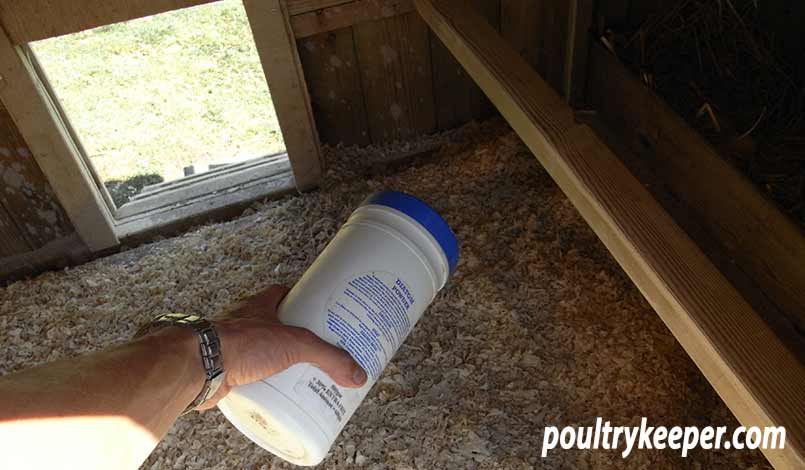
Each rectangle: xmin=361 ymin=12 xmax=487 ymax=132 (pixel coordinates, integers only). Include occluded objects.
xmin=197 ymin=285 xmax=366 ymax=410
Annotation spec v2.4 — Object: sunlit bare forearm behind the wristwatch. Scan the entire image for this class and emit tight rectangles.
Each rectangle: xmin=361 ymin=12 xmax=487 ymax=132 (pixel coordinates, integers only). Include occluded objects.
xmin=0 ymin=328 xmax=204 ymax=468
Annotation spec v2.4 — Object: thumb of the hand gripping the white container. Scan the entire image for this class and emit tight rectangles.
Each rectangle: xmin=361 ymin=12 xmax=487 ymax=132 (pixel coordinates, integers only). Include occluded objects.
xmin=287 ymin=327 xmax=366 ymax=388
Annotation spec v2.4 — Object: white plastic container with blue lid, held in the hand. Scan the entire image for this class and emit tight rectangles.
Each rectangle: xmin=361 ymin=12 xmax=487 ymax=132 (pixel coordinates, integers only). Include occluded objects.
xmin=218 ymin=191 xmax=458 ymax=465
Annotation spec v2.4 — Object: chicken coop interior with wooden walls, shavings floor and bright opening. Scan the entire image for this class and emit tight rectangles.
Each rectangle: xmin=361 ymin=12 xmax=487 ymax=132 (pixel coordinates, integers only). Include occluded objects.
xmin=0 ymin=0 xmax=805 ymax=470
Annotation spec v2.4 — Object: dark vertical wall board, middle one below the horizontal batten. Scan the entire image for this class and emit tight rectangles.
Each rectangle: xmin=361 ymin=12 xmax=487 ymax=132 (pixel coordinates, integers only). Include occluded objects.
xmin=355 ymin=12 xmax=436 ymax=143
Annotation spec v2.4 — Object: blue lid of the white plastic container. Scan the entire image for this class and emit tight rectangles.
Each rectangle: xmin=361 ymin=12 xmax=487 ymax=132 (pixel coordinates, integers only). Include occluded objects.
xmin=361 ymin=191 xmax=458 ymax=273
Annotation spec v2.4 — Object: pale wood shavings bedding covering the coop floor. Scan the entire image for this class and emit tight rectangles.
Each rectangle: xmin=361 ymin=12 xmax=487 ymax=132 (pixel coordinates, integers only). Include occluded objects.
xmin=0 ymin=121 xmax=768 ymax=470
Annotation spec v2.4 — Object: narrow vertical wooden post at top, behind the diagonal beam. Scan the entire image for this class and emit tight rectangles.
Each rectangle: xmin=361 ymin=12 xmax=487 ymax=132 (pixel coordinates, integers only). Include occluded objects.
xmin=562 ymin=0 xmax=593 ymax=103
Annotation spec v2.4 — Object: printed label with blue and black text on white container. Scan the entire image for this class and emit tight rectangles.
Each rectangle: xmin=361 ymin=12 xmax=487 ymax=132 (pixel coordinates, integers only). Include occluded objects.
xmin=294 ymin=271 xmax=415 ymax=435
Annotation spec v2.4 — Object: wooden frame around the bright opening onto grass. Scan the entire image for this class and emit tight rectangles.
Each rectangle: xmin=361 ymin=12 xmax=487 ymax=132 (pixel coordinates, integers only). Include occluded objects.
xmin=0 ymin=0 xmax=322 ymax=251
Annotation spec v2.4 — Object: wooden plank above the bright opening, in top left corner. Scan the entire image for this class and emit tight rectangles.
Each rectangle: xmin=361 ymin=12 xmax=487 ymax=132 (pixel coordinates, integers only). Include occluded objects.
xmin=0 ymin=0 xmax=213 ymax=44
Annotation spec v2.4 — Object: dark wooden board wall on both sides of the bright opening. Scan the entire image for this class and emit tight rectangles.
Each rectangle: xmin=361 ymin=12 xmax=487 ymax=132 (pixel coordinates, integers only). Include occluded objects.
xmin=0 ymin=0 xmax=576 ymax=282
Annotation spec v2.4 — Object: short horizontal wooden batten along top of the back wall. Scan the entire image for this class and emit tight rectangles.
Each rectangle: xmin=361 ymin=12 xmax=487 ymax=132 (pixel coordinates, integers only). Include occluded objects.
xmin=291 ymin=0 xmax=414 ymax=38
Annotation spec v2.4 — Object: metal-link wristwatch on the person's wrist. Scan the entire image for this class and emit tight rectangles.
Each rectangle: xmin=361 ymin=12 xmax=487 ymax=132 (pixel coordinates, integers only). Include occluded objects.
xmin=134 ymin=313 xmax=226 ymax=415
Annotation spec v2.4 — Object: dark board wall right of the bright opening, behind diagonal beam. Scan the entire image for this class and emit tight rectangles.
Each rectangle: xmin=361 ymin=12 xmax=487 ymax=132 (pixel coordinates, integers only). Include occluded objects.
xmin=289 ymin=0 xmax=570 ymax=145
